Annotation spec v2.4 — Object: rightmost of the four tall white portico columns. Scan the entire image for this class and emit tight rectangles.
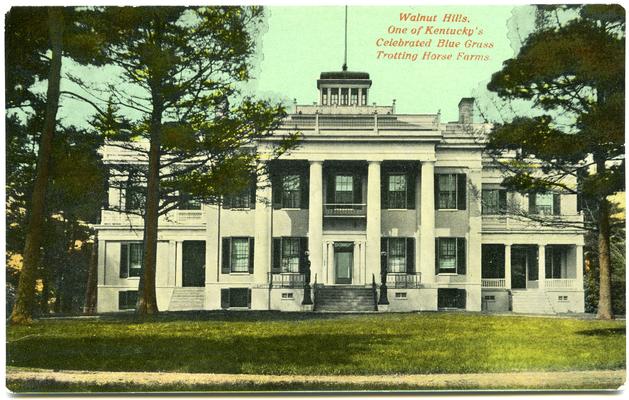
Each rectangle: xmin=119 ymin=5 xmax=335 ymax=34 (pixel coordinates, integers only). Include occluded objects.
xmin=419 ymin=161 xmax=435 ymax=283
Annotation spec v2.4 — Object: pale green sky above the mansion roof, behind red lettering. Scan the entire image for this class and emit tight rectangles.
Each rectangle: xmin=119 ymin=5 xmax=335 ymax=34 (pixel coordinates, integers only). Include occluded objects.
xmin=251 ymin=6 xmax=528 ymax=121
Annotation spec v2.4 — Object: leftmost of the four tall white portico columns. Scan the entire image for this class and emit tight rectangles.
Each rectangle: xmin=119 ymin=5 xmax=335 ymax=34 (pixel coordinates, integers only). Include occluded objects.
xmin=253 ymin=176 xmax=272 ymax=283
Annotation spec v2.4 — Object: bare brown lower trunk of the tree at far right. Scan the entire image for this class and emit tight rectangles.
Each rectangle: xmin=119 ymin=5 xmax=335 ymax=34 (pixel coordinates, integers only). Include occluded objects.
xmin=596 ymin=198 xmax=614 ymax=319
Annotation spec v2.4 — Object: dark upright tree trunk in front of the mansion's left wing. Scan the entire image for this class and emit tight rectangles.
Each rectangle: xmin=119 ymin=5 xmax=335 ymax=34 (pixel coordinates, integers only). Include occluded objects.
xmin=137 ymin=93 xmax=163 ymax=316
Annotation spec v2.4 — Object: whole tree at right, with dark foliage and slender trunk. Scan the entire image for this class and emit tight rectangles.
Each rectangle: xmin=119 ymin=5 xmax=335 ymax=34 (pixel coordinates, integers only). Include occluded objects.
xmin=487 ymin=5 xmax=625 ymax=319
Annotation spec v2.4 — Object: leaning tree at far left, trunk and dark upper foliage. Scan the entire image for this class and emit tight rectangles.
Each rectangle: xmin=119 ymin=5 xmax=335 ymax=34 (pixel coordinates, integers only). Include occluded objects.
xmin=5 ymin=7 xmax=106 ymax=324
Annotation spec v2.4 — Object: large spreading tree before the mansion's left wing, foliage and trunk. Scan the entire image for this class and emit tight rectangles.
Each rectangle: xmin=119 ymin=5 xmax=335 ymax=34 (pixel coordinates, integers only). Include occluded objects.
xmin=72 ymin=7 xmax=295 ymax=315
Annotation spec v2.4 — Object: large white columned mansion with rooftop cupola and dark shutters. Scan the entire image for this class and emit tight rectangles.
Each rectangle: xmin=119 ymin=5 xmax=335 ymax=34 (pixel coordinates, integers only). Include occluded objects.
xmin=97 ymin=67 xmax=584 ymax=314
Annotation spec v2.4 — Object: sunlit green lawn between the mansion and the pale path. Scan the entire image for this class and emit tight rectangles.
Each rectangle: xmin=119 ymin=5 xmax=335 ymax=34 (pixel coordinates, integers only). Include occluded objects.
xmin=7 ymin=312 xmax=625 ymax=376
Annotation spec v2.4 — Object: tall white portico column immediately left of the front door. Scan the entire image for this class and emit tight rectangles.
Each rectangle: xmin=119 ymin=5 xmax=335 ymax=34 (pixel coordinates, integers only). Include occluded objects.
xmin=308 ymin=161 xmax=323 ymax=279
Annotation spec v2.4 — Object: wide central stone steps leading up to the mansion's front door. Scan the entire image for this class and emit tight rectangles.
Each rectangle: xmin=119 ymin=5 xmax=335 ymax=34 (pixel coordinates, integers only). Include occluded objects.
xmin=314 ymin=286 xmax=376 ymax=312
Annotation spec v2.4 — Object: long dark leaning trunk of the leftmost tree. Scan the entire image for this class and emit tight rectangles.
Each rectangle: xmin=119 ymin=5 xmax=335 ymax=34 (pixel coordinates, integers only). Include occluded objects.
xmin=9 ymin=7 xmax=64 ymax=324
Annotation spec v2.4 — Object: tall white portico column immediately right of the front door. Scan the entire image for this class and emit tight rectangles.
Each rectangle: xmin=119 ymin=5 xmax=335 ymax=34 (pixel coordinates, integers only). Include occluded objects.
xmin=365 ymin=161 xmax=381 ymax=282
